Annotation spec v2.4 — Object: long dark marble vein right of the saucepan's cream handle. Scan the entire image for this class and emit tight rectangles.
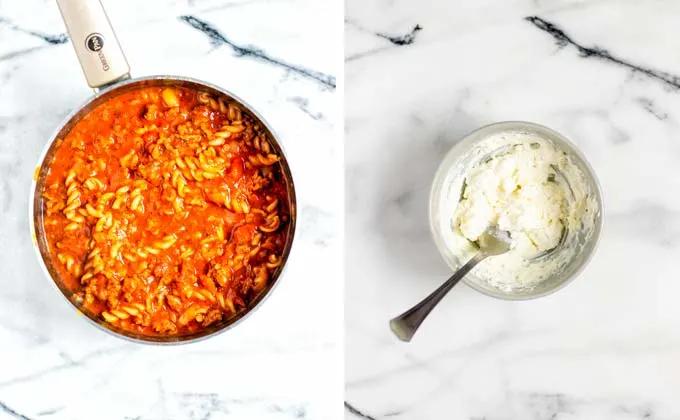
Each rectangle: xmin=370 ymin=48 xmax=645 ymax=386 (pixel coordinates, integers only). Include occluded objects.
xmin=179 ymin=15 xmax=336 ymax=89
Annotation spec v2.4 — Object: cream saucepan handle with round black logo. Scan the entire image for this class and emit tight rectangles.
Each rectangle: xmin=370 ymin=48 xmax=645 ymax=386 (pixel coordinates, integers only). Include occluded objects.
xmin=57 ymin=0 xmax=130 ymax=90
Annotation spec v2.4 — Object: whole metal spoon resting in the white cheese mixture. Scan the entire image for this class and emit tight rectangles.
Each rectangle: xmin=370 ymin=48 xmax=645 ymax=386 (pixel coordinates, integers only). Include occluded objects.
xmin=390 ymin=226 xmax=513 ymax=342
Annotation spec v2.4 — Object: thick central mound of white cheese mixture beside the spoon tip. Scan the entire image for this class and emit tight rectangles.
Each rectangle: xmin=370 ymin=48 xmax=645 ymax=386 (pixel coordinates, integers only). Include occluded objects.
xmin=455 ymin=143 xmax=569 ymax=258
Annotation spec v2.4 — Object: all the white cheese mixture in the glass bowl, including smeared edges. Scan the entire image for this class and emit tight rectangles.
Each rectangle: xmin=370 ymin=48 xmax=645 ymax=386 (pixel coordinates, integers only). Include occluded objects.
xmin=451 ymin=135 xmax=597 ymax=291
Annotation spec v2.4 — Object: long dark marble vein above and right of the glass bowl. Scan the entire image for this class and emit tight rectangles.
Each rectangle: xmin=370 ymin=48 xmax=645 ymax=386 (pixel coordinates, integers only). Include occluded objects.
xmin=524 ymin=16 xmax=680 ymax=89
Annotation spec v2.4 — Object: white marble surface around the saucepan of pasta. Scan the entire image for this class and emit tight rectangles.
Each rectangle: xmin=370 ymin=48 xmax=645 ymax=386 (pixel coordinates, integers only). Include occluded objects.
xmin=0 ymin=0 xmax=342 ymax=420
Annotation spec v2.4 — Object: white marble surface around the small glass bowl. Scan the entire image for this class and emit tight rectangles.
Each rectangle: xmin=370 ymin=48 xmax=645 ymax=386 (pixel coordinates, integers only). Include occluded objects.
xmin=345 ymin=0 xmax=680 ymax=420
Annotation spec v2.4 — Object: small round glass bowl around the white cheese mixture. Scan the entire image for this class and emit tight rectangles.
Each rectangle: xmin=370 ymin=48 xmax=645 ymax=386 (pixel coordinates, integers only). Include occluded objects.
xmin=430 ymin=121 xmax=604 ymax=300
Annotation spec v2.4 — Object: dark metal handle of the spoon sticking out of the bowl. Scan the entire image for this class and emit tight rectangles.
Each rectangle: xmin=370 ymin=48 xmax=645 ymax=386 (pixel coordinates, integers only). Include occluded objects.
xmin=390 ymin=253 xmax=487 ymax=342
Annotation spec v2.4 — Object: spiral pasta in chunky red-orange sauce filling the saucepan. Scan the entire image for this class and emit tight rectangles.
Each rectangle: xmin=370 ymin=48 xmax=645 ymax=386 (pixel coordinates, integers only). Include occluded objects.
xmin=42 ymin=87 xmax=290 ymax=335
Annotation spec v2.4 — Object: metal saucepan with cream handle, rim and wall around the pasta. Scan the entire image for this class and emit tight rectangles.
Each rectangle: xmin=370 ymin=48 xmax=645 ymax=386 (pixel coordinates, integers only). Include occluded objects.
xmin=29 ymin=0 xmax=296 ymax=344
